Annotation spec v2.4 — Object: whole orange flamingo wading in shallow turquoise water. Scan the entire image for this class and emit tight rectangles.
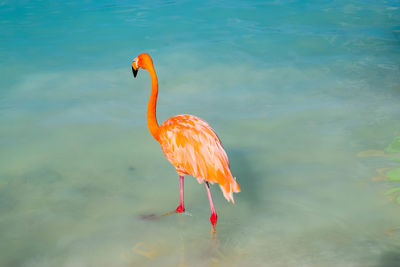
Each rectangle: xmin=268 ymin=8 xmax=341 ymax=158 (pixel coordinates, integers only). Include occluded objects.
xmin=132 ymin=53 xmax=240 ymax=232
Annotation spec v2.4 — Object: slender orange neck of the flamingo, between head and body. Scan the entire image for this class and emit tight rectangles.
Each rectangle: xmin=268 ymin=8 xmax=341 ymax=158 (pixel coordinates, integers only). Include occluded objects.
xmin=147 ymin=66 xmax=160 ymax=141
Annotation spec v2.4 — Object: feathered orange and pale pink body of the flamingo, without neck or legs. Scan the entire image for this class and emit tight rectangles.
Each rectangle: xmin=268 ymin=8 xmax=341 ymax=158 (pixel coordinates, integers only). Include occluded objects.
xmin=159 ymin=115 xmax=240 ymax=202
